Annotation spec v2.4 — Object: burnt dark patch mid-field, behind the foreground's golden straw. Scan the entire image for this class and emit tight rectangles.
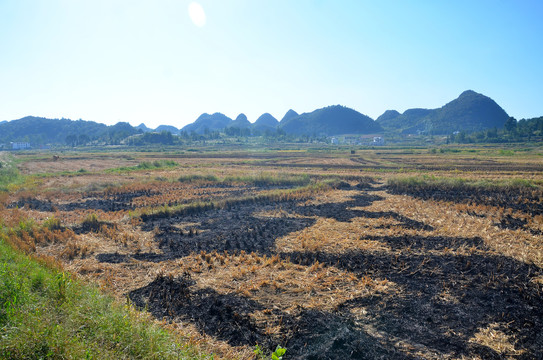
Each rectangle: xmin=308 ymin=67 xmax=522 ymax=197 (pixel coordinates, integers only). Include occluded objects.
xmin=129 ymin=192 xmax=432 ymax=261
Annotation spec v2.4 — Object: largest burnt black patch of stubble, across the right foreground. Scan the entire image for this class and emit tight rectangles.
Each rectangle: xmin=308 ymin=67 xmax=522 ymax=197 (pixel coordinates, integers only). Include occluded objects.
xmin=129 ymin=232 xmax=543 ymax=359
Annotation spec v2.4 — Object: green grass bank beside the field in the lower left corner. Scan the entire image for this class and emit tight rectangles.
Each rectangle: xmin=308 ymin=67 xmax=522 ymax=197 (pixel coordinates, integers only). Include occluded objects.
xmin=0 ymin=222 xmax=206 ymax=359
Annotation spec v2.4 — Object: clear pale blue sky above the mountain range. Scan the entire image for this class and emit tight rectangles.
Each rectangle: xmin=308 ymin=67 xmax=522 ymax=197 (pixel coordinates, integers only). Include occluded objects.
xmin=0 ymin=0 xmax=543 ymax=127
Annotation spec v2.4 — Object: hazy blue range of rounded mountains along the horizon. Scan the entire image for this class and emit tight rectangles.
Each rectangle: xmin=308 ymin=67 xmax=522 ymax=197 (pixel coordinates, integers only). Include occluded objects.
xmin=0 ymin=90 xmax=509 ymax=144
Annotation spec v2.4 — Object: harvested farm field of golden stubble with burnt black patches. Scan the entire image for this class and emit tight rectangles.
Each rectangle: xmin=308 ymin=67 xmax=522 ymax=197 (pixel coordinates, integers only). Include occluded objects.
xmin=0 ymin=147 xmax=543 ymax=359
